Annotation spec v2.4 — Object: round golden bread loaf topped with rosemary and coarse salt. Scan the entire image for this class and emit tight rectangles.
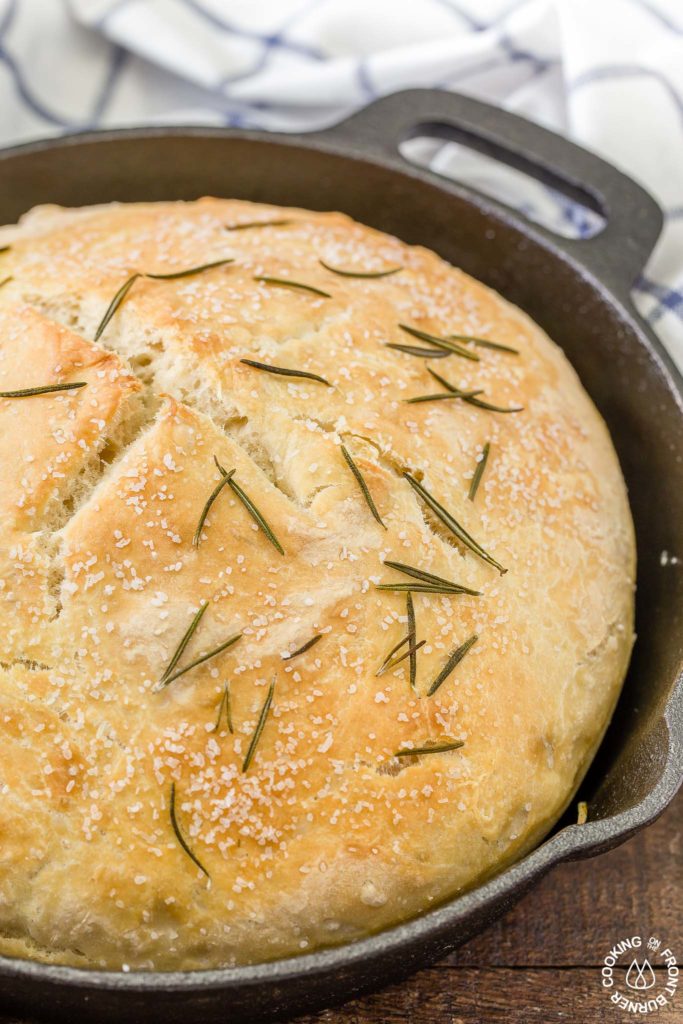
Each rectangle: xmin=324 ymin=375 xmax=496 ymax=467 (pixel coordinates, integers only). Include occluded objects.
xmin=0 ymin=199 xmax=635 ymax=970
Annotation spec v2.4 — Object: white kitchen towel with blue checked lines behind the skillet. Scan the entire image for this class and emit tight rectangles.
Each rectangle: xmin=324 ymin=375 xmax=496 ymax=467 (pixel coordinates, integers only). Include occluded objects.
xmin=0 ymin=0 xmax=683 ymax=367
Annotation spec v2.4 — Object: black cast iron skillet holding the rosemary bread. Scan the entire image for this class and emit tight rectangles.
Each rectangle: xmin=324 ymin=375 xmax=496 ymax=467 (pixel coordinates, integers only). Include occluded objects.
xmin=0 ymin=91 xmax=683 ymax=1024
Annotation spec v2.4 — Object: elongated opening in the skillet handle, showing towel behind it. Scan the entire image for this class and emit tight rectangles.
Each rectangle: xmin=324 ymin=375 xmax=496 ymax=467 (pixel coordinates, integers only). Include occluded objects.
xmin=399 ymin=123 xmax=606 ymax=239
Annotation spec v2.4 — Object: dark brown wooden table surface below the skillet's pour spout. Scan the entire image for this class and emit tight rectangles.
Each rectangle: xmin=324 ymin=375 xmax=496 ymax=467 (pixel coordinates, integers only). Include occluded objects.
xmin=296 ymin=793 xmax=683 ymax=1024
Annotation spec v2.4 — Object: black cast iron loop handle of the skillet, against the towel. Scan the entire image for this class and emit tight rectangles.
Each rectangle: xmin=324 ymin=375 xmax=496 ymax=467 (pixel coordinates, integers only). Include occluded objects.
xmin=321 ymin=89 xmax=663 ymax=294
